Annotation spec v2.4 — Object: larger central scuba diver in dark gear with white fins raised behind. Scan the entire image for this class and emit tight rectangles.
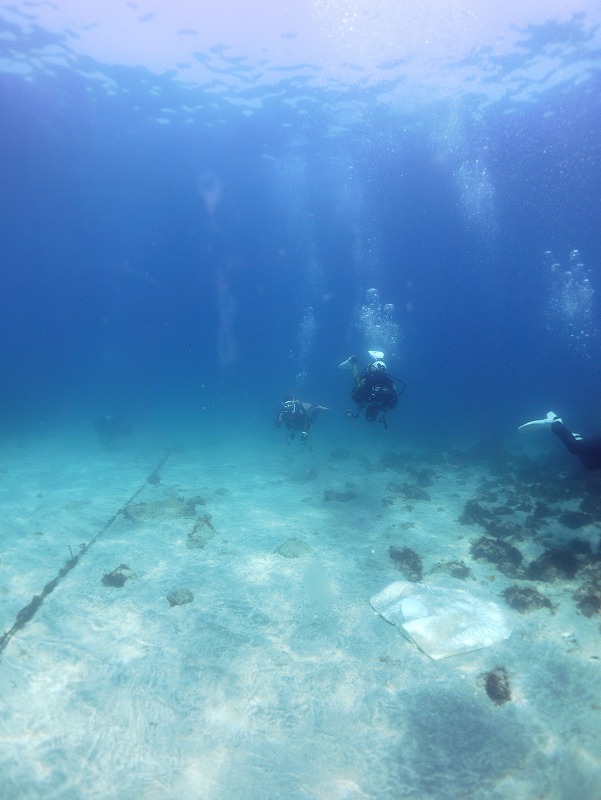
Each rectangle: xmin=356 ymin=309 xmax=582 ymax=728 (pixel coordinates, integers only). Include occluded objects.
xmin=338 ymin=350 xmax=405 ymax=428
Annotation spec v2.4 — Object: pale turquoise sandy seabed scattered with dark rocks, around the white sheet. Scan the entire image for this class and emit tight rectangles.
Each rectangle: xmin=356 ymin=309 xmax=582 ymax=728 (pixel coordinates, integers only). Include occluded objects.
xmin=0 ymin=422 xmax=601 ymax=800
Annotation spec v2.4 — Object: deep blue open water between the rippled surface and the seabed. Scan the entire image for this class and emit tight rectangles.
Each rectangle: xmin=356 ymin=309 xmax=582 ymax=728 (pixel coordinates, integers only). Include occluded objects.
xmin=0 ymin=6 xmax=601 ymax=441
